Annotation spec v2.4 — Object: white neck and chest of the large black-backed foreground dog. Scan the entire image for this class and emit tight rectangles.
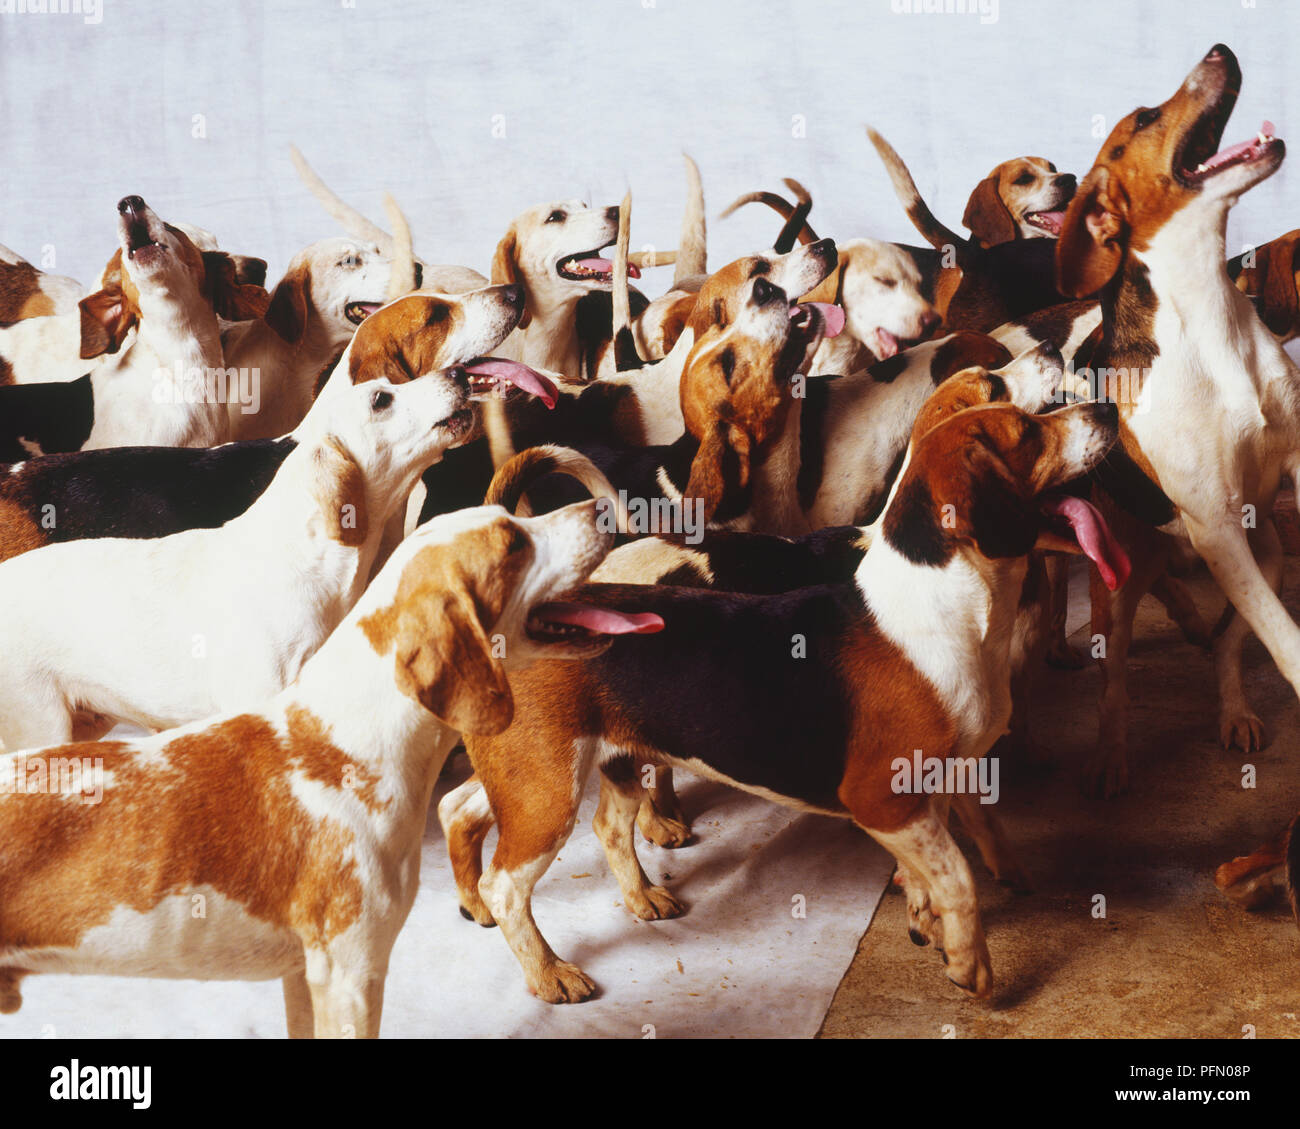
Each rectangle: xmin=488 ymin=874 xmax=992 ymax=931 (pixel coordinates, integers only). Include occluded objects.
xmin=854 ymin=527 xmax=1028 ymax=756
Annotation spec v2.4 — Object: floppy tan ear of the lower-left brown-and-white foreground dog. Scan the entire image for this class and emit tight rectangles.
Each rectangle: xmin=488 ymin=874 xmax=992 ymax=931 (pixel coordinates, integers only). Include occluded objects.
xmin=395 ymin=587 xmax=515 ymax=736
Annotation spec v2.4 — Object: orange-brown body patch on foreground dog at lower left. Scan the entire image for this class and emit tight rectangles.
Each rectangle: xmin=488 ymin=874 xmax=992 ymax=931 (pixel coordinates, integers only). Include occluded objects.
xmin=0 ymin=711 xmax=377 ymax=950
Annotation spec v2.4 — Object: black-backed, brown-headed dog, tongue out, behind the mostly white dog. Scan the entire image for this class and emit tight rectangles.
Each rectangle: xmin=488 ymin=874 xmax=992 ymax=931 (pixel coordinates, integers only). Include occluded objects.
xmin=0 ymin=286 xmax=550 ymax=561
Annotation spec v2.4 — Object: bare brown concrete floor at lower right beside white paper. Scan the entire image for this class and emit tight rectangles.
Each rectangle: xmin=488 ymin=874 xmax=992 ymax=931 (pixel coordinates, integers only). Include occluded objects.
xmin=820 ymin=558 xmax=1300 ymax=1038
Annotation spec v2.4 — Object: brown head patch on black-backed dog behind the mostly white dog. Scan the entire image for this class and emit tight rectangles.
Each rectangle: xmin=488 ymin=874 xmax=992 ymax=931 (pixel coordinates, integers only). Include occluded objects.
xmin=347 ymin=294 xmax=464 ymax=384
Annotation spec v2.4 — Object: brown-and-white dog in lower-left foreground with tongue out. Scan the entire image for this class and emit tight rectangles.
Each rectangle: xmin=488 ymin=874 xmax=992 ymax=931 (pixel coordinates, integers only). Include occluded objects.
xmin=0 ymin=499 xmax=662 ymax=1038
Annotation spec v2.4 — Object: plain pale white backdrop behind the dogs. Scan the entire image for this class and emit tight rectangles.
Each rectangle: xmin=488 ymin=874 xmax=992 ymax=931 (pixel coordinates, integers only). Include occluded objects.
xmin=0 ymin=0 xmax=1300 ymax=293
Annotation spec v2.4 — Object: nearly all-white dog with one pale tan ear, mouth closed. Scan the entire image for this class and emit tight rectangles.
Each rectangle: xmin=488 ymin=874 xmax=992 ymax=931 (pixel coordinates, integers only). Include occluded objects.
xmin=0 ymin=372 xmax=473 ymax=750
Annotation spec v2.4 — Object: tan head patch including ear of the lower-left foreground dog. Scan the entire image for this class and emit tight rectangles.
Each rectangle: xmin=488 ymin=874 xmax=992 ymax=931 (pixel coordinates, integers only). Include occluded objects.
xmin=358 ymin=518 xmax=533 ymax=734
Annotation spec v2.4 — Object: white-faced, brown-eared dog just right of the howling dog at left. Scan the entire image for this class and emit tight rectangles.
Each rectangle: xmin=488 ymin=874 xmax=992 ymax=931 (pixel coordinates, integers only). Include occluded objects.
xmin=221 ymin=238 xmax=410 ymax=440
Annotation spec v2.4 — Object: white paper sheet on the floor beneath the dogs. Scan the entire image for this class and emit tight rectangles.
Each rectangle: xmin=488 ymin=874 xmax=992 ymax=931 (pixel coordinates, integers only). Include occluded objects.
xmin=0 ymin=757 xmax=893 ymax=1038
